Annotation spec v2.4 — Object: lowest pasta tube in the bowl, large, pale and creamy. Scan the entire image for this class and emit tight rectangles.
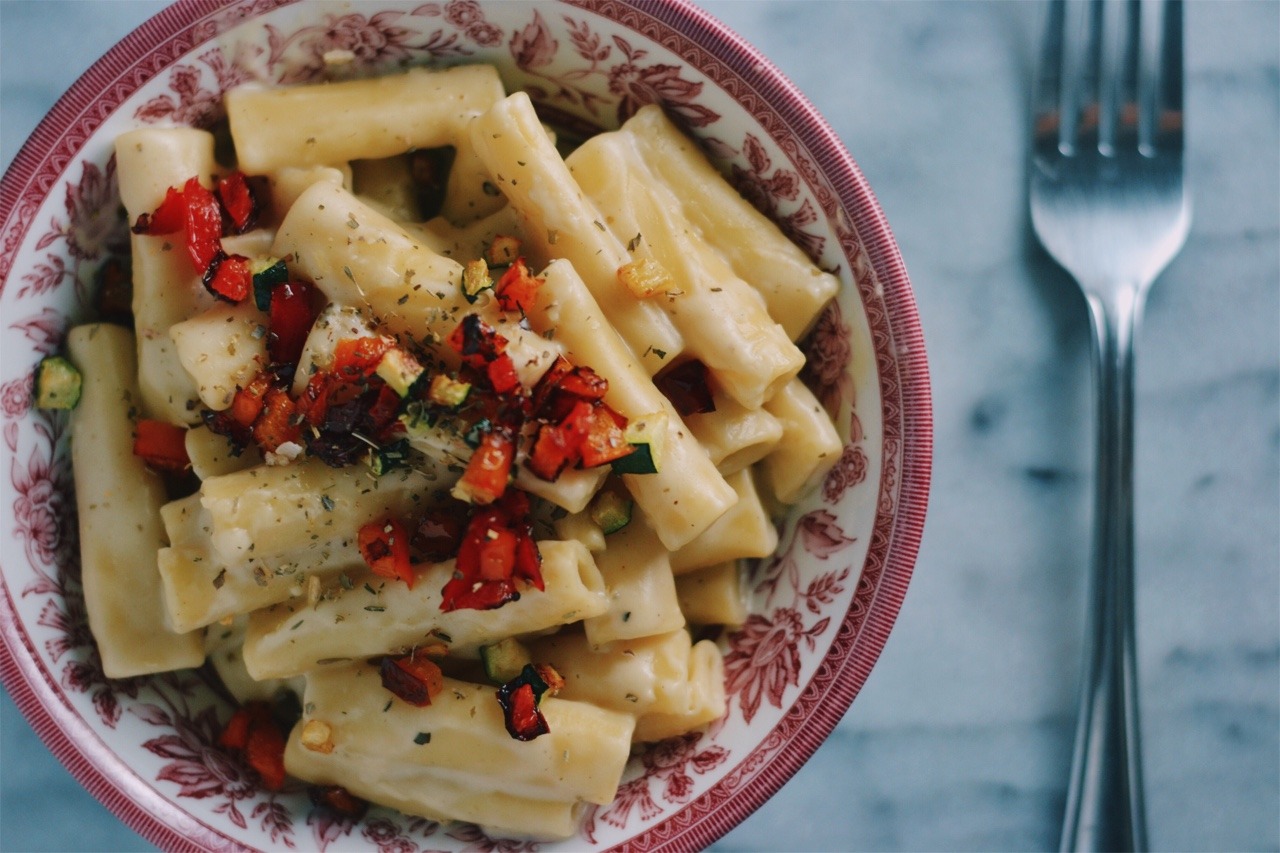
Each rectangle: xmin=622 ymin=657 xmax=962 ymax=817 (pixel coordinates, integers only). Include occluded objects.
xmin=284 ymin=663 xmax=635 ymax=838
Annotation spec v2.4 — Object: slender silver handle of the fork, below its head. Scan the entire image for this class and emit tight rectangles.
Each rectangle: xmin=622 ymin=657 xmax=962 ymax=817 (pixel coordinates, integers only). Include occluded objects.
xmin=1061 ymin=284 xmax=1147 ymax=850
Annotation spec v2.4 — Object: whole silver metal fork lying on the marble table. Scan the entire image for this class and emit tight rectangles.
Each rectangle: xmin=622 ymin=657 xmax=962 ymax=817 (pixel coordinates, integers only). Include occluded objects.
xmin=1030 ymin=0 xmax=1190 ymax=850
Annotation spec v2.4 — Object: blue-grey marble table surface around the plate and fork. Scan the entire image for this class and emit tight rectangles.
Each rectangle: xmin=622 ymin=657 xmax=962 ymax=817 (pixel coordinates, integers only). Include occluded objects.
xmin=0 ymin=0 xmax=1280 ymax=850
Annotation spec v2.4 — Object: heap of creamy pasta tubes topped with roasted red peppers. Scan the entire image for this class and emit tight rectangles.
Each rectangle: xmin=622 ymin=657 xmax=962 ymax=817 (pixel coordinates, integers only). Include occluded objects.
xmin=57 ymin=58 xmax=841 ymax=838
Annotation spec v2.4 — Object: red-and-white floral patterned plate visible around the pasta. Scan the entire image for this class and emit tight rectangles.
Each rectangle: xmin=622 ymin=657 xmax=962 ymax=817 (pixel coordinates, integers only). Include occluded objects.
xmin=0 ymin=0 xmax=932 ymax=852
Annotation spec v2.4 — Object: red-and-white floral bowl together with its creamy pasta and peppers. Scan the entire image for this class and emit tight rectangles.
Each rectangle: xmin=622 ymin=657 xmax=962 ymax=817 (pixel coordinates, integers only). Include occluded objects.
xmin=0 ymin=0 xmax=932 ymax=850
